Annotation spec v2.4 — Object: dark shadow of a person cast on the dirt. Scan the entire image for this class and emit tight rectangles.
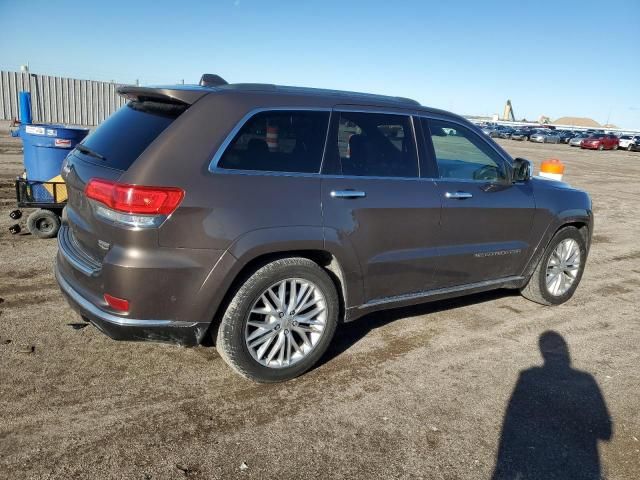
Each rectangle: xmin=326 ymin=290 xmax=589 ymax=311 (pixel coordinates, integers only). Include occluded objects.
xmin=493 ymin=331 xmax=612 ymax=480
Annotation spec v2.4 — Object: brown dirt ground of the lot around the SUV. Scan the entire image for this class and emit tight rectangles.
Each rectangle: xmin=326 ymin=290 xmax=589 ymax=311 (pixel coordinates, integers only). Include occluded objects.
xmin=0 ymin=132 xmax=640 ymax=479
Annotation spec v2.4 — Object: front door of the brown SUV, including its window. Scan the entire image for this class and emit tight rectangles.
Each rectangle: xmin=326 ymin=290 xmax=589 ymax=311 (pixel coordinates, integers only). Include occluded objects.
xmin=421 ymin=118 xmax=535 ymax=287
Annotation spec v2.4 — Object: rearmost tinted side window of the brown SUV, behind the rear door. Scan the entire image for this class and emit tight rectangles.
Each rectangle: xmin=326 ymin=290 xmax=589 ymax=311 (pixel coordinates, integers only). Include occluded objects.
xmin=218 ymin=111 xmax=329 ymax=173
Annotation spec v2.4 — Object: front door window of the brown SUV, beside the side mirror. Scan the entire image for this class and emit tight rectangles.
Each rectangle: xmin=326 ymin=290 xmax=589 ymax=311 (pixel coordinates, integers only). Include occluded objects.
xmin=422 ymin=119 xmax=507 ymax=182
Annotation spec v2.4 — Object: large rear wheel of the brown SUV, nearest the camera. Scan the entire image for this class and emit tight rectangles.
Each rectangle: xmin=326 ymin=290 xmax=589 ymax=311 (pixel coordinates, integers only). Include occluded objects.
xmin=216 ymin=257 xmax=340 ymax=383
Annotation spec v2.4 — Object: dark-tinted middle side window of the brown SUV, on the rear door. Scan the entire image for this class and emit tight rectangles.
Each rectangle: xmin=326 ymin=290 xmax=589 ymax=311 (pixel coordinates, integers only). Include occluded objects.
xmin=337 ymin=112 xmax=418 ymax=177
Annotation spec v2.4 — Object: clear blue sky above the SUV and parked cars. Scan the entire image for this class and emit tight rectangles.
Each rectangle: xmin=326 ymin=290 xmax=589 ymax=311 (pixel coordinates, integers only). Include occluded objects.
xmin=0 ymin=0 xmax=640 ymax=129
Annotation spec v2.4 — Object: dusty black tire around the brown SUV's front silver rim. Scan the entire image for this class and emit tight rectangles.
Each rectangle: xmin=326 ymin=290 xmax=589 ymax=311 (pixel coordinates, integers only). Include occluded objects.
xmin=520 ymin=227 xmax=587 ymax=305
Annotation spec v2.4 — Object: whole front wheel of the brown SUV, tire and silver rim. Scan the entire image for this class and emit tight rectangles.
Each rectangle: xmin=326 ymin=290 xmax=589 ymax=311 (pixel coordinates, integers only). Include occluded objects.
xmin=520 ymin=227 xmax=587 ymax=305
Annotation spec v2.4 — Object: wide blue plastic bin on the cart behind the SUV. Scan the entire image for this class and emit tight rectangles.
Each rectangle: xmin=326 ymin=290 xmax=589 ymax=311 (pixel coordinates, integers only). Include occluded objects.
xmin=14 ymin=124 xmax=89 ymax=201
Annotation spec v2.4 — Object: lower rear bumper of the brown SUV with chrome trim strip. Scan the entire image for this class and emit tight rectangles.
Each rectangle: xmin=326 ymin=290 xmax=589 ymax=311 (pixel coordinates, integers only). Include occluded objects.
xmin=55 ymin=262 xmax=210 ymax=346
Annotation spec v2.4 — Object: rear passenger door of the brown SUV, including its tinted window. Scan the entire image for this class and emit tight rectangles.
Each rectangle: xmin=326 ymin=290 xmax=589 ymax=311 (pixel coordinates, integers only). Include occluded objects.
xmin=322 ymin=108 xmax=441 ymax=303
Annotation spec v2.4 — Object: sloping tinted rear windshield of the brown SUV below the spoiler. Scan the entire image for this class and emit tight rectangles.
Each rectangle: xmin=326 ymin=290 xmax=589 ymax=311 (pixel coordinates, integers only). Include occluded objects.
xmin=76 ymin=101 xmax=187 ymax=170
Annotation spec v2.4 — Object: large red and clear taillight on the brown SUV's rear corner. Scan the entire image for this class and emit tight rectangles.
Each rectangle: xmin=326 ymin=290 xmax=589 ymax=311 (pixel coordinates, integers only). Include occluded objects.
xmin=84 ymin=178 xmax=184 ymax=227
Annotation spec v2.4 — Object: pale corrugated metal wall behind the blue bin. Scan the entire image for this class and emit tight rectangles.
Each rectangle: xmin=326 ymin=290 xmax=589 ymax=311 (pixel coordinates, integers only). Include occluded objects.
xmin=0 ymin=71 xmax=125 ymax=126
